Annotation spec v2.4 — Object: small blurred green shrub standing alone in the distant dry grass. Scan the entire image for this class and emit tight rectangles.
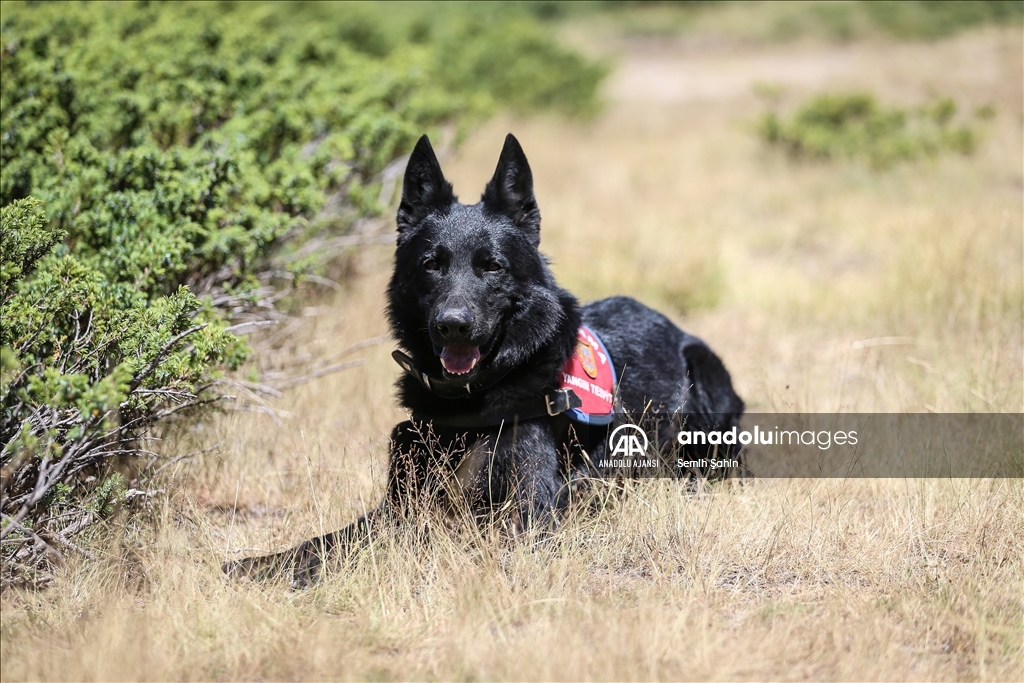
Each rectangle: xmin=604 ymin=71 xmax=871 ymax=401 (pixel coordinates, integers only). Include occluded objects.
xmin=757 ymin=93 xmax=980 ymax=168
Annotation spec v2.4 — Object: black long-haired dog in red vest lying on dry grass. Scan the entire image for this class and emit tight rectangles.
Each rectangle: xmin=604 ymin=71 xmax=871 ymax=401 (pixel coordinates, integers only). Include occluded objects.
xmin=224 ymin=135 xmax=743 ymax=585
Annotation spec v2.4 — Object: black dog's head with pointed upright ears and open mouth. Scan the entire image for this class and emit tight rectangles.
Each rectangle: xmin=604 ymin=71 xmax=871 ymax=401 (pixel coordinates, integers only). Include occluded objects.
xmin=388 ymin=134 xmax=565 ymax=383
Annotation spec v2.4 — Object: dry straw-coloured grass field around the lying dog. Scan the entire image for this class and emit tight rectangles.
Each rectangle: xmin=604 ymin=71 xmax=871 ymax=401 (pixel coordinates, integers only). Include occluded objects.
xmin=0 ymin=12 xmax=1024 ymax=681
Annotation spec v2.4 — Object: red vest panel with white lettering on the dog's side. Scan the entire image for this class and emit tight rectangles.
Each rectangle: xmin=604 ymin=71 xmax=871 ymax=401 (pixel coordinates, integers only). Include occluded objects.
xmin=559 ymin=326 xmax=615 ymax=425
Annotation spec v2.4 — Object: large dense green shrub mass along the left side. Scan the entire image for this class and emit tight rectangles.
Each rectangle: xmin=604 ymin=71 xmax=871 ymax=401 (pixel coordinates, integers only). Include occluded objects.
xmin=0 ymin=2 xmax=605 ymax=580
